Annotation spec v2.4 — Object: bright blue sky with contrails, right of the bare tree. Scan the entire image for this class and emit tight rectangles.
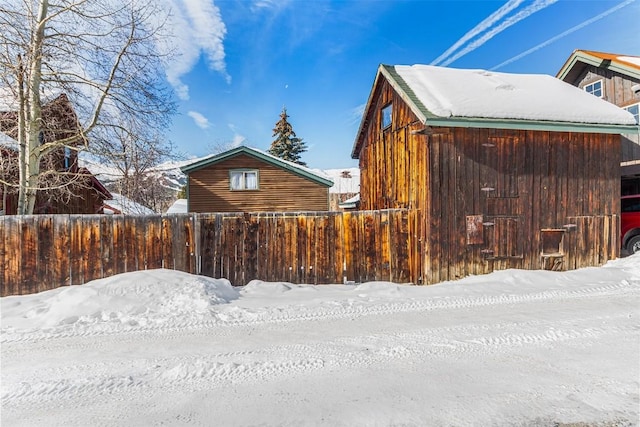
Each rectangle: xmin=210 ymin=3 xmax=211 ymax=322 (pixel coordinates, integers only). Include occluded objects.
xmin=167 ymin=0 xmax=640 ymax=169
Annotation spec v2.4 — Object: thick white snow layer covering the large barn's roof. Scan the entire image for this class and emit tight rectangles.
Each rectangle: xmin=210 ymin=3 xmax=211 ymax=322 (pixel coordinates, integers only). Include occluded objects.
xmin=392 ymin=65 xmax=635 ymax=125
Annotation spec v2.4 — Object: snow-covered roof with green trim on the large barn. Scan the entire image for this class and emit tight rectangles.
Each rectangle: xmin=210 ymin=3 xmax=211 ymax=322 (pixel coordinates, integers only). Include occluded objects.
xmin=352 ymin=64 xmax=638 ymax=158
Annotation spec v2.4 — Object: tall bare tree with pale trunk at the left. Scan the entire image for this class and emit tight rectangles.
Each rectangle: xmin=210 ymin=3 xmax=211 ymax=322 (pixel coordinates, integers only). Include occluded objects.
xmin=0 ymin=0 xmax=174 ymax=214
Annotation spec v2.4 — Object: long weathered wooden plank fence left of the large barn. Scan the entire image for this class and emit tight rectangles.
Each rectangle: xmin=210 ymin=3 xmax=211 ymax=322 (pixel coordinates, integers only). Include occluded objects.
xmin=0 ymin=210 xmax=421 ymax=296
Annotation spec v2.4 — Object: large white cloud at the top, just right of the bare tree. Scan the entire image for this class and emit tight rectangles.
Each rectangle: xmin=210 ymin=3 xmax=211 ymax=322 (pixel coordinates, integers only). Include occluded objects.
xmin=158 ymin=0 xmax=231 ymax=100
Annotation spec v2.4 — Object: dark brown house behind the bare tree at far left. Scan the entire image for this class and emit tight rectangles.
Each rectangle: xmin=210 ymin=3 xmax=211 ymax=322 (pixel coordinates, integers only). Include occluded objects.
xmin=0 ymin=94 xmax=112 ymax=215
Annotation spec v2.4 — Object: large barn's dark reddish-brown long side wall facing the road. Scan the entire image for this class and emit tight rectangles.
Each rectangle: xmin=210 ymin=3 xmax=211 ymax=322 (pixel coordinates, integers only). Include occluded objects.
xmin=424 ymin=128 xmax=620 ymax=283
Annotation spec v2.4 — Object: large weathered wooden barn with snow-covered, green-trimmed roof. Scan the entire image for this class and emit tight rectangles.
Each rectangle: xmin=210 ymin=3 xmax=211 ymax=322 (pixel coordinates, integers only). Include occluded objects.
xmin=352 ymin=65 xmax=636 ymax=284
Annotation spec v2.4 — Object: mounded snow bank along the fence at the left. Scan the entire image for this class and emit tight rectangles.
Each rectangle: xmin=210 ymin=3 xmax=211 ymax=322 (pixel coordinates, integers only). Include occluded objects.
xmin=1 ymin=269 xmax=239 ymax=333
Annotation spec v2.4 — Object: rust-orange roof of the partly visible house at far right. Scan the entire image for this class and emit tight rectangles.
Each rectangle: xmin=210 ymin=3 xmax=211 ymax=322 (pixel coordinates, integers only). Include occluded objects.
xmin=556 ymin=49 xmax=640 ymax=82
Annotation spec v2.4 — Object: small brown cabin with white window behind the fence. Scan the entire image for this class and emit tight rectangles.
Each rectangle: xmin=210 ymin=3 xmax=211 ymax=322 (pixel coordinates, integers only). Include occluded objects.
xmin=181 ymin=147 xmax=333 ymax=212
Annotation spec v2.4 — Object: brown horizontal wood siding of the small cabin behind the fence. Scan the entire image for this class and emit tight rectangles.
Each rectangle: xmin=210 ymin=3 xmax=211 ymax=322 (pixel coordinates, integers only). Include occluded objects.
xmin=189 ymin=154 xmax=329 ymax=212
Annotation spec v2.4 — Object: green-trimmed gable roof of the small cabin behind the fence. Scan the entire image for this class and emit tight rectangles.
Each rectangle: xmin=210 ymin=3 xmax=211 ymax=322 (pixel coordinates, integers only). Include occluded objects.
xmin=180 ymin=146 xmax=333 ymax=187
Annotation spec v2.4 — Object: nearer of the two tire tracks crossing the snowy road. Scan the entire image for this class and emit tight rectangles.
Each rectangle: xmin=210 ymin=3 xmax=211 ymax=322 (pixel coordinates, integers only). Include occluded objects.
xmin=1 ymin=315 xmax=639 ymax=406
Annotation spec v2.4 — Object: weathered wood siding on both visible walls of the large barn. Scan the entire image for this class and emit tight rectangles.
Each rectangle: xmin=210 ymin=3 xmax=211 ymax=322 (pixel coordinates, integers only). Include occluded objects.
xmin=357 ymin=74 xmax=620 ymax=283
